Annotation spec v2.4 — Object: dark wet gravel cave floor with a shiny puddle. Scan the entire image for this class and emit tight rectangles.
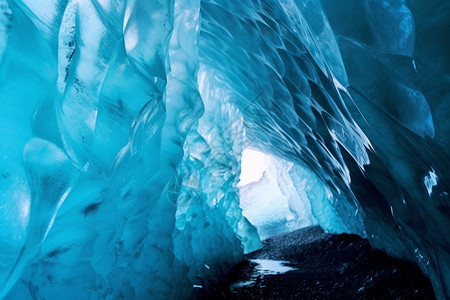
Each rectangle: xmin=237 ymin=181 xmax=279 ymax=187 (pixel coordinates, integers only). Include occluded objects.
xmin=196 ymin=227 xmax=435 ymax=299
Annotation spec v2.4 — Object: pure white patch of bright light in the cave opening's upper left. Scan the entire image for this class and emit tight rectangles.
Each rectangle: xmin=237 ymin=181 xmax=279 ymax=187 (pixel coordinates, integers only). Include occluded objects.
xmin=238 ymin=148 xmax=268 ymax=186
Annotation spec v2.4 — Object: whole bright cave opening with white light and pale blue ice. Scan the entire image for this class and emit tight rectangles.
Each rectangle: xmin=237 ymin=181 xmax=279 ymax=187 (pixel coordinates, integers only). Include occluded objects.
xmin=238 ymin=147 xmax=317 ymax=240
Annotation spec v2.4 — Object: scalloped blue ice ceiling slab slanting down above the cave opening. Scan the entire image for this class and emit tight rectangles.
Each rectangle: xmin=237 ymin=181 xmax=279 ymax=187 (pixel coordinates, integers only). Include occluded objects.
xmin=200 ymin=1 xmax=369 ymax=238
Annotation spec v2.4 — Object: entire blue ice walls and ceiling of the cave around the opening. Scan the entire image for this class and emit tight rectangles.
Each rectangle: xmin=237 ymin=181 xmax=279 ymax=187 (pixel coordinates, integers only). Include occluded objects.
xmin=0 ymin=0 xmax=450 ymax=299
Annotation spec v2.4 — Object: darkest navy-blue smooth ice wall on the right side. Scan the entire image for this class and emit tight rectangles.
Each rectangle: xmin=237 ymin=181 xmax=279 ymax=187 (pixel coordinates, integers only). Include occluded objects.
xmin=323 ymin=0 xmax=450 ymax=298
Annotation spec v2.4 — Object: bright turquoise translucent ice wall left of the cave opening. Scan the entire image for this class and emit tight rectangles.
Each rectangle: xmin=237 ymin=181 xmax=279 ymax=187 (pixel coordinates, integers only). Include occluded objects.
xmin=0 ymin=0 xmax=260 ymax=299
